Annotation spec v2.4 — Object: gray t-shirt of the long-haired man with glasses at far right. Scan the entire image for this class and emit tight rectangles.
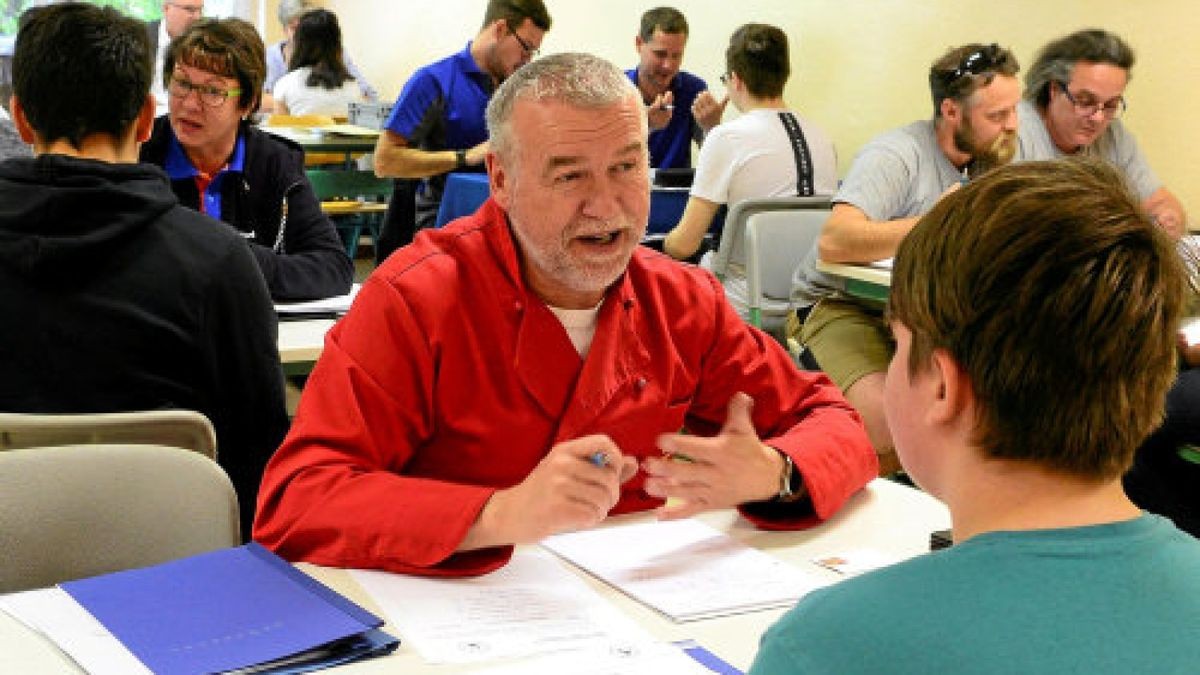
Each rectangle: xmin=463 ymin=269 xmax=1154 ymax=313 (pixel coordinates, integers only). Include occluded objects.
xmin=1014 ymin=101 xmax=1163 ymax=199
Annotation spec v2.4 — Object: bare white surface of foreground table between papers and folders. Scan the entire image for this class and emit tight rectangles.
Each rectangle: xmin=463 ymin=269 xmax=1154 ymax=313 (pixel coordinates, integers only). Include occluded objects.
xmin=0 ymin=479 xmax=949 ymax=675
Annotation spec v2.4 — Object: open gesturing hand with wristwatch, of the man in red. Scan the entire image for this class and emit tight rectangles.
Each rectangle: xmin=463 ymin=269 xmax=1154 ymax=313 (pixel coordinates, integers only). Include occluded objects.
xmin=642 ymin=393 xmax=784 ymax=519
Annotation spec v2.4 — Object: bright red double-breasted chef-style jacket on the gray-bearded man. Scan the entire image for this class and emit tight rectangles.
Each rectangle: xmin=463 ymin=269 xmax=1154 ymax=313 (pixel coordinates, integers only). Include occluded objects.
xmin=254 ymin=201 xmax=877 ymax=575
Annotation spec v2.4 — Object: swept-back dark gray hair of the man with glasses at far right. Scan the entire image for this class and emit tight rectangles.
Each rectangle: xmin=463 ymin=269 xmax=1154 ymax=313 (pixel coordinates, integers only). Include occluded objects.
xmin=1025 ymin=28 xmax=1134 ymax=108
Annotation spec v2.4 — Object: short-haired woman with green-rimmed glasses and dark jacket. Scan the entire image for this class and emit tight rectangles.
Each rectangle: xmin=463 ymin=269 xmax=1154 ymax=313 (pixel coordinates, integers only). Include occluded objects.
xmin=142 ymin=18 xmax=354 ymax=300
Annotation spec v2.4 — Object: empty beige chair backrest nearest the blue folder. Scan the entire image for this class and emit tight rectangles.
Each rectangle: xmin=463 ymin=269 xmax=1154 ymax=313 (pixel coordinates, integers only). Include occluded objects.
xmin=0 ymin=444 xmax=241 ymax=593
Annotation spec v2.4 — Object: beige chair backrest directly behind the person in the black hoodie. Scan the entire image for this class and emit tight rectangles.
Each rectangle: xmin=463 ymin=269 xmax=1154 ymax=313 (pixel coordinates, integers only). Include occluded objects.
xmin=0 ymin=410 xmax=217 ymax=459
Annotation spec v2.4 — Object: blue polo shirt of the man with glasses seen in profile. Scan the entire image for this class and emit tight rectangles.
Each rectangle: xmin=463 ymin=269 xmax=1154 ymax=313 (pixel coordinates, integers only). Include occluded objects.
xmin=384 ymin=42 xmax=493 ymax=227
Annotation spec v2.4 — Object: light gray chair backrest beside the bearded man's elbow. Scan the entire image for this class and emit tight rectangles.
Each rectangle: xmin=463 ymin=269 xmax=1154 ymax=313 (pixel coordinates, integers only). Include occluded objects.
xmin=743 ymin=199 xmax=830 ymax=328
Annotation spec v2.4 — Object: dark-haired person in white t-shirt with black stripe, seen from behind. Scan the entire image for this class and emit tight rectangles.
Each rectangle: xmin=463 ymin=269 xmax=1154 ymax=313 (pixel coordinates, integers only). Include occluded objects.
xmin=662 ymin=24 xmax=838 ymax=315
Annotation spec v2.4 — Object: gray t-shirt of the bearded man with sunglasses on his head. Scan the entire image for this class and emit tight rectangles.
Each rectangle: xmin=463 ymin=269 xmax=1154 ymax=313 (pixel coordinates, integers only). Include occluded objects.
xmin=792 ymin=120 xmax=961 ymax=306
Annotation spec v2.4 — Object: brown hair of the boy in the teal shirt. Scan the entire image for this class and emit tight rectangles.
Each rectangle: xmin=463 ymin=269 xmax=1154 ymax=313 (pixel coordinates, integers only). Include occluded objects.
xmin=888 ymin=160 xmax=1187 ymax=479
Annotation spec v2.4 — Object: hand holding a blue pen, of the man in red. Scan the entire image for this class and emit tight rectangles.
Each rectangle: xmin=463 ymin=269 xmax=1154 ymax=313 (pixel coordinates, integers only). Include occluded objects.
xmin=458 ymin=435 xmax=637 ymax=550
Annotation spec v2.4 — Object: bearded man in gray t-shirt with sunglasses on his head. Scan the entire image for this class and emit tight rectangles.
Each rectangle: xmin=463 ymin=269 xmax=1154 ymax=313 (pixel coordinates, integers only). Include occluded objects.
xmin=787 ymin=44 xmax=1020 ymax=474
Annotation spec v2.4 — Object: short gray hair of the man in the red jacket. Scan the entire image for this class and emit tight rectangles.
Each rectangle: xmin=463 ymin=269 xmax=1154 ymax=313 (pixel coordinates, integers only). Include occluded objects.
xmin=487 ymin=53 xmax=637 ymax=157
